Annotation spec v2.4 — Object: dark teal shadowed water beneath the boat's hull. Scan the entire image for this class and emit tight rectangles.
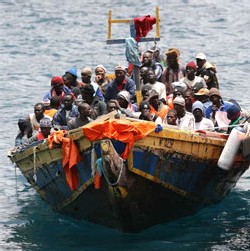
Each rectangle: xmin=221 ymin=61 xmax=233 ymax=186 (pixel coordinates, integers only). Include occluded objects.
xmin=6 ymin=183 xmax=250 ymax=250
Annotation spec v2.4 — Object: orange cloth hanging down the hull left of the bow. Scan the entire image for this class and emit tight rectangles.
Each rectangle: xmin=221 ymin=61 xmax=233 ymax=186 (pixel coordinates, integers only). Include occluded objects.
xmin=48 ymin=130 xmax=81 ymax=191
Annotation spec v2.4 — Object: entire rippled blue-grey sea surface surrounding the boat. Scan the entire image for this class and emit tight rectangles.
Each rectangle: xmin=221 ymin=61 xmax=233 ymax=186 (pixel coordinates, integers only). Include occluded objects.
xmin=0 ymin=0 xmax=250 ymax=251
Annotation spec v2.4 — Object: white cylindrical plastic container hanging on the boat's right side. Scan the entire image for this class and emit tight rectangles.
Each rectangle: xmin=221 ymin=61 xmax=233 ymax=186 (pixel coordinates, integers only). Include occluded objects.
xmin=218 ymin=127 xmax=246 ymax=170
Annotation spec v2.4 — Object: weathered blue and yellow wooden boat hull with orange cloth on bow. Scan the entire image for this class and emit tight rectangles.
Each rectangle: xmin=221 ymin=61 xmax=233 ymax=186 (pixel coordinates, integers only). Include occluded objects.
xmin=7 ymin=114 xmax=250 ymax=232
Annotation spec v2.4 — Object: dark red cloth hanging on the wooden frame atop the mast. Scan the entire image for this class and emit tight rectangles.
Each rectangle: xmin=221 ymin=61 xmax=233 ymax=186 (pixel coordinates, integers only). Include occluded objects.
xmin=134 ymin=15 xmax=156 ymax=42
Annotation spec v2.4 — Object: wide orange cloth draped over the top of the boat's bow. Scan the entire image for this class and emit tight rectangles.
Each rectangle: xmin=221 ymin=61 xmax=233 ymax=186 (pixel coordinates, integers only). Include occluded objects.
xmin=82 ymin=119 xmax=155 ymax=159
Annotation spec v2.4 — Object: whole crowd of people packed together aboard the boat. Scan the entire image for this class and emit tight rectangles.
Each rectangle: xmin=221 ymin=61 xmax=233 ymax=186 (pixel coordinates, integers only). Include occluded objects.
xmin=15 ymin=46 xmax=248 ymax=146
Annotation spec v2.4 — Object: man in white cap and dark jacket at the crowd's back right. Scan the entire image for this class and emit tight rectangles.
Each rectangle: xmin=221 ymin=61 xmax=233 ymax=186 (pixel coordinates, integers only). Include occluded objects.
xmin=196 ymin=53 xmax=219 ymax=90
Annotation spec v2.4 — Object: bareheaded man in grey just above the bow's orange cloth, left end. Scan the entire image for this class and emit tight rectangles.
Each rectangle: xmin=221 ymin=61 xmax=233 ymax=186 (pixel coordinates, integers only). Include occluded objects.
xmin=68 ymin=102 xmax=93 ymax=130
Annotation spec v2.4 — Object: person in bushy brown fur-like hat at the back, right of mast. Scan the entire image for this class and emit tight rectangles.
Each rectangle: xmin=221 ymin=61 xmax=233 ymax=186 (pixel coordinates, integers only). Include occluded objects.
xmin=161 ymin=48 xmax=185 ymax=95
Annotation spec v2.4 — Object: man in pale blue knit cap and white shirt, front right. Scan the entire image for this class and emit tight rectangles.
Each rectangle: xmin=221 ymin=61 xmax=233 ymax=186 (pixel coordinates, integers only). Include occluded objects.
xmin=192 ymin=101 xmax=214 ymax=131
